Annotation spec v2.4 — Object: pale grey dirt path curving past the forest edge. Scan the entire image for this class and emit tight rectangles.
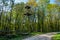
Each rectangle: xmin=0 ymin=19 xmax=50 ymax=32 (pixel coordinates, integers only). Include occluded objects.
xmin=23 ymin=32 xmax=57 ymax=40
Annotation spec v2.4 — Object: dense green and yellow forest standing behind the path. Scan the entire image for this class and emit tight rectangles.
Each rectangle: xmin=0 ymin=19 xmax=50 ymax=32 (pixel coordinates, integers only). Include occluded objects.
xmin=0 ymin=0 xmax=60 ymax=35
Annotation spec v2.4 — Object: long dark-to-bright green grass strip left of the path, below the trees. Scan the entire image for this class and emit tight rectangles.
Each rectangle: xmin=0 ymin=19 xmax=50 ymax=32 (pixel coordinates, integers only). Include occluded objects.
xmin=0 ymin=32 xmax=42 ymax=40
